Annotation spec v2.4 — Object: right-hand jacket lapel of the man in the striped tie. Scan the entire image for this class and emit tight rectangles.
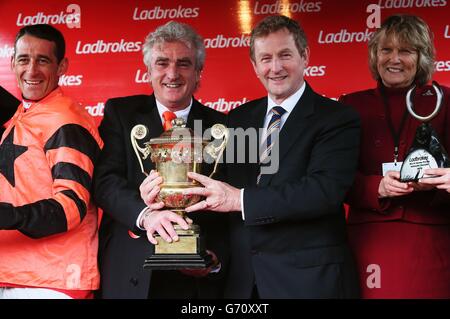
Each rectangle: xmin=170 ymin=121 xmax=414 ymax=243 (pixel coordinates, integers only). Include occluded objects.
xmin=259 ymin=83 xmax=316 ymax=186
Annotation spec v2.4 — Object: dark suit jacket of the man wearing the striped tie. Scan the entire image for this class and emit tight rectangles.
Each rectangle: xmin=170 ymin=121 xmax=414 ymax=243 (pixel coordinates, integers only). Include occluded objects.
xmin=225 ymin=84 xmax=359 ymax=298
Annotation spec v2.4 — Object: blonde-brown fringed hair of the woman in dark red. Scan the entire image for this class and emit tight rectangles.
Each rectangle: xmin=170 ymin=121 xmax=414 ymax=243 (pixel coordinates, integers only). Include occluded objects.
xmin=369 ymin=14 xmax=435 ymax=85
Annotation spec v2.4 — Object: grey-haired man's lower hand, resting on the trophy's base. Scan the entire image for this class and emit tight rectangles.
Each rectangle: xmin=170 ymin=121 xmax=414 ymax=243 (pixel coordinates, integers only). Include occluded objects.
xmin=140 ymin=211 xmax=192 ymax=245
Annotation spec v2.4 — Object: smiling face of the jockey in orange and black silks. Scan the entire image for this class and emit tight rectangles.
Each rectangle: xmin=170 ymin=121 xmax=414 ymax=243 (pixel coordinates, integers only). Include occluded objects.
xmin=11 ymin=34 xmax=67 ymax=101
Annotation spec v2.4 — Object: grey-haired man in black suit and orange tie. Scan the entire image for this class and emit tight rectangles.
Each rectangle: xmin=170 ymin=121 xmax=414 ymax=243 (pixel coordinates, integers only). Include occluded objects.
xmin=94 ymin=22 xmax=226 ymax=298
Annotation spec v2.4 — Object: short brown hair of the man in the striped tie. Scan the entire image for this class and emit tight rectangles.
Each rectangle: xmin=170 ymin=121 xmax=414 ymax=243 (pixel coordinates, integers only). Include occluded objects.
xmin=250 ymin=15 xmax=308 ymax=61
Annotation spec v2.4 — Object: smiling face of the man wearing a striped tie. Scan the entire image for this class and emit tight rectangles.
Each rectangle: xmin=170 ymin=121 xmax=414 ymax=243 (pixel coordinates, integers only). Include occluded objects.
xmin=252 ymin=29 xmax=309 ymax=104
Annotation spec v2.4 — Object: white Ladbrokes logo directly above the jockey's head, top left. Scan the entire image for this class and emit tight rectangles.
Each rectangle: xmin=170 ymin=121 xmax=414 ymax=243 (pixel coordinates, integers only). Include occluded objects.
xmin=16 ymin=4 xmax=81 ymax=28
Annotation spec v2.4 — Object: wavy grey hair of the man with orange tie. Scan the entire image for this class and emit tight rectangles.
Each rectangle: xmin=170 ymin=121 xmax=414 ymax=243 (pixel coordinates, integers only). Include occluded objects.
xmin=142 ymin=21 xmax=206 ymax=71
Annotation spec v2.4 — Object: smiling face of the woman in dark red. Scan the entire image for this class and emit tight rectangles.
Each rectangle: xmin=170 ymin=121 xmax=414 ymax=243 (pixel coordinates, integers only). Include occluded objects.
xmin=377 ymin=36 xmax=419 ymax=88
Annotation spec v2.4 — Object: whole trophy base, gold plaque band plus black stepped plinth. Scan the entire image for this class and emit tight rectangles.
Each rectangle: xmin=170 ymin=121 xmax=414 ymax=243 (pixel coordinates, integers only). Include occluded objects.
xmin=144 ymin=225 xmax=212 ymax=270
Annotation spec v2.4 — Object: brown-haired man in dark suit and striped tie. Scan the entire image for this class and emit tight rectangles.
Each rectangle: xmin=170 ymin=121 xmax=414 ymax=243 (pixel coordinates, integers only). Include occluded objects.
xmin=181 ymin=16 xmax=359 ymax=298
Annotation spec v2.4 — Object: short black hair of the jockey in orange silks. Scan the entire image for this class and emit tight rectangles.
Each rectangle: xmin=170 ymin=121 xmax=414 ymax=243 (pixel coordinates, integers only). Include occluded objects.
xmin=14 ymin=24 xmax=66 ymax=63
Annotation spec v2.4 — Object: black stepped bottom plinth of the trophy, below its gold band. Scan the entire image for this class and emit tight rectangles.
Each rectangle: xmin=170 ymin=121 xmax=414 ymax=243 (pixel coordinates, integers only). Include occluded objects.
xmin=144 ymin=252 xmax=212 ymax=270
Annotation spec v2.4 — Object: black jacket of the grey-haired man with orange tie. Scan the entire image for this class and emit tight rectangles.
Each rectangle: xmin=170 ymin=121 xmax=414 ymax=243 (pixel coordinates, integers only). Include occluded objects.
xmin=94 ymin=95 xmax=228 ymax=298
